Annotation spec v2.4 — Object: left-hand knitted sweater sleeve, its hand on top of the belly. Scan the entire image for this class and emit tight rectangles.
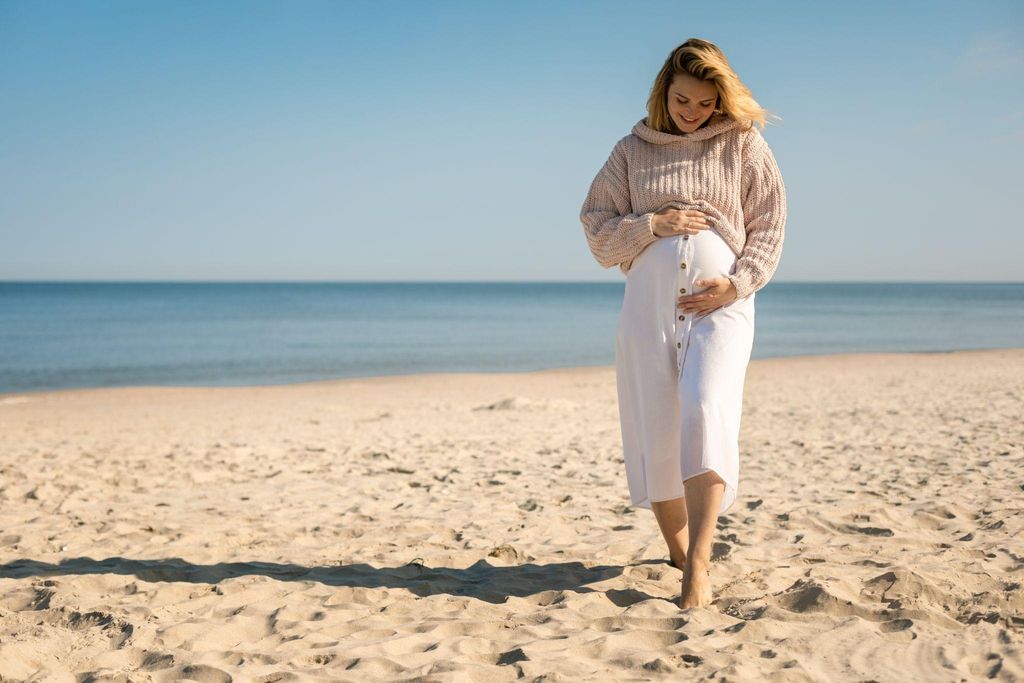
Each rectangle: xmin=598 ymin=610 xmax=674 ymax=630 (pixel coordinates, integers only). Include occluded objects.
xmin=580 ymin=138 xmax=658 ymax=269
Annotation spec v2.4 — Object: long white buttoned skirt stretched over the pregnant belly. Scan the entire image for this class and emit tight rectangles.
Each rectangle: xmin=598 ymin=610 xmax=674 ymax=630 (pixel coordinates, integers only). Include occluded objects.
xmin=615 ymin=227 xmax=755 ymax=514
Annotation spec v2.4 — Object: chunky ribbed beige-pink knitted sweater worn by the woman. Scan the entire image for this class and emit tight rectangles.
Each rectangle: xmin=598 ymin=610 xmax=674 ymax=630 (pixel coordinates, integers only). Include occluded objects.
xmin=580 ymin=114 xmax=786 ymax=299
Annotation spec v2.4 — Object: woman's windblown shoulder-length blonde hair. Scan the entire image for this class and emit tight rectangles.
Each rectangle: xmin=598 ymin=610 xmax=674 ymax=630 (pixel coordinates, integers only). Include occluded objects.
xmin=647 ymin=38 xmax=779 ymax=134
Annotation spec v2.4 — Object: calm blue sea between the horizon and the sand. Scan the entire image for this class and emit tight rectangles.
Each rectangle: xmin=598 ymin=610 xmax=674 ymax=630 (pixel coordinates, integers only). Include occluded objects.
xmin=0 ymin=282 xmax=1024 ymax=393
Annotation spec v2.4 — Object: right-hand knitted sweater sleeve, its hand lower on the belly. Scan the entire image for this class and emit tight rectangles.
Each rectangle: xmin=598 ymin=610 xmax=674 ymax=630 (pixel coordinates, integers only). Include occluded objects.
xmin=728 ymin=144 xmax=786 ymax=299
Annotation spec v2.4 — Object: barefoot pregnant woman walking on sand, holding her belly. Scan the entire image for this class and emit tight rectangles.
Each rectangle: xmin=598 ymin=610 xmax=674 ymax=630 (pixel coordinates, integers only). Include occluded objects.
xmin=580 ymin=38 xmax=786 ymax=608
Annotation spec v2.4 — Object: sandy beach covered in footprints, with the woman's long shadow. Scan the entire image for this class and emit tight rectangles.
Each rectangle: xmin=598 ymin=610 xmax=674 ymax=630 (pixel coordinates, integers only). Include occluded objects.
xmin=0 ymin=349 xmax=1024 ymax=682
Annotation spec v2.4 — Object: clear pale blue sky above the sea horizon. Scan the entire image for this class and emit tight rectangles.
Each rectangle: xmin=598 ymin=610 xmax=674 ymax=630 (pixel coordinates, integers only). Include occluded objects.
xmin=0 ymin=0 xmax=1024 ymax=282
